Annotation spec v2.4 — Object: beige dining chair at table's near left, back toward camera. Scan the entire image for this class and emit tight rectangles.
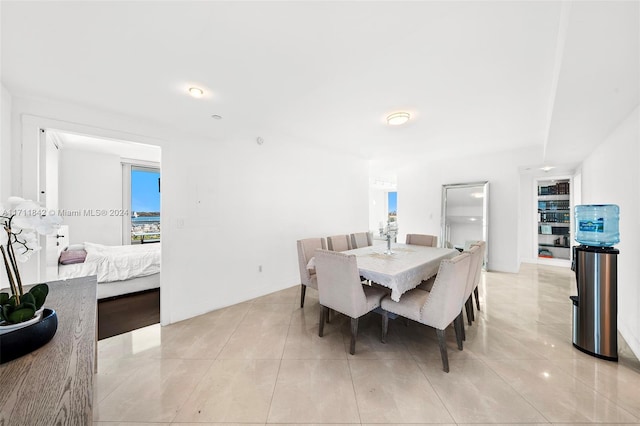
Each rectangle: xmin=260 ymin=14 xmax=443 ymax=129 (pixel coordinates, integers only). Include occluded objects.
xmin=315 ymin=250 xmax=387 ymax=355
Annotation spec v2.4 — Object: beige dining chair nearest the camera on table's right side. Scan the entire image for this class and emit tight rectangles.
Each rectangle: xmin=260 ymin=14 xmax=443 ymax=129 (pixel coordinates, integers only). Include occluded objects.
xmin=380 ymin=253 xmax=471 ymax=373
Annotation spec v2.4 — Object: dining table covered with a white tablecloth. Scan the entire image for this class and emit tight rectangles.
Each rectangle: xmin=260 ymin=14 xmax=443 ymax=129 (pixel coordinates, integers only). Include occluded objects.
xmin=308 ymin=243 xmax=460 ymax=302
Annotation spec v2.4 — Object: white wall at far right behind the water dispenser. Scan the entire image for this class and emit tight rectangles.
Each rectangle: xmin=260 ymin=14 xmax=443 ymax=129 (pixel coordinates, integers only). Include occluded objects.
xmin=582 ymin=107 xmax=640 ymax=357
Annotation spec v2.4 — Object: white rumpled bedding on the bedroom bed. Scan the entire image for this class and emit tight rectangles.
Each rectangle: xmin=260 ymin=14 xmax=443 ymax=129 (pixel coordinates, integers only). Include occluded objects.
xmin=58 ymin=243 xmax=161 ymax=283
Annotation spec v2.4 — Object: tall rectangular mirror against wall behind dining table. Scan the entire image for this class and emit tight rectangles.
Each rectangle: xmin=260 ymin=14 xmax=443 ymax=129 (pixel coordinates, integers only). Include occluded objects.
xmin=440 ymin=181 xmax=489 ymax=268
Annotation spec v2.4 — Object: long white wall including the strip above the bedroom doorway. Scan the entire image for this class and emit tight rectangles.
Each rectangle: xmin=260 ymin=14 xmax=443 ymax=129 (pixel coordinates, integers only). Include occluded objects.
xmin=12 ymin=98 xmax=369 ymax=324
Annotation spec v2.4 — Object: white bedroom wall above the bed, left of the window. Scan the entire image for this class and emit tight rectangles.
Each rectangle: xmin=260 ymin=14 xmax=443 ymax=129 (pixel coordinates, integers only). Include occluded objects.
xmin=58 ymin=147 xmax=122 ymax=245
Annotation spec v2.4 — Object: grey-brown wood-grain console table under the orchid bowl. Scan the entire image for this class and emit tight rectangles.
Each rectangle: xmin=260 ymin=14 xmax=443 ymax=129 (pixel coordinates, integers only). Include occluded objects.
xmin=0 ymin=276 xmax=97 ymax=426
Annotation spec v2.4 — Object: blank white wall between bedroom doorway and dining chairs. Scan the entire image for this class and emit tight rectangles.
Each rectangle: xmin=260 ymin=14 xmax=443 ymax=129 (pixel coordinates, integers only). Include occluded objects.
xmin=162 ymin=133 xmax=368 ymax=319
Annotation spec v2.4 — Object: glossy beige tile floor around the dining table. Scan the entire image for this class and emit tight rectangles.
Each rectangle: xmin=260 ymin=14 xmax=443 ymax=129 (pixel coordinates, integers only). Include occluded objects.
xmin=94 ymin=264 xmax=640 ymax=426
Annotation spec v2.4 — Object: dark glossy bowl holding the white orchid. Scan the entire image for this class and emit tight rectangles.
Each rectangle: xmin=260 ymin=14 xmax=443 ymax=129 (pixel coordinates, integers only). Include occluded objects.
xmin=0 ymin=309 xmax=58 ymax=364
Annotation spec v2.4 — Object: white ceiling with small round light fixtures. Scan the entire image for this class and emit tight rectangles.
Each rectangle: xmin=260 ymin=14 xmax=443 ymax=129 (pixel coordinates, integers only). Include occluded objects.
xmin=0 ymin=1 xmax=640 ymax=164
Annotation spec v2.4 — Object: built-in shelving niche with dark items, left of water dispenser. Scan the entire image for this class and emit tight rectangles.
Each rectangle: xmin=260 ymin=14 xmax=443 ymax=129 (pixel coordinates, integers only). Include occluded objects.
xmin=538 ymin=179 xmax=571 ymax=260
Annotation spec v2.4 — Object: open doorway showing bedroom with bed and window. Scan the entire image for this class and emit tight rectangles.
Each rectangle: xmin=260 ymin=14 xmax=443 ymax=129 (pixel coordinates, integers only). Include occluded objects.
xmin=43 ymin=130 xmax=161 ymax=339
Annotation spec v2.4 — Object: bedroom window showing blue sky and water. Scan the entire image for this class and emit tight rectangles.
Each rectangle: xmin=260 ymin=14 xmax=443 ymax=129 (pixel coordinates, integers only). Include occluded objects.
xmin=131 ymin=167 xmax=160 ymax=244
